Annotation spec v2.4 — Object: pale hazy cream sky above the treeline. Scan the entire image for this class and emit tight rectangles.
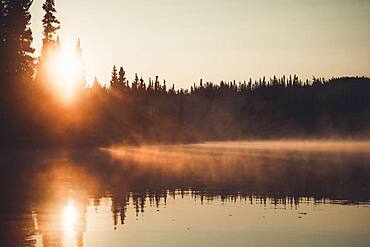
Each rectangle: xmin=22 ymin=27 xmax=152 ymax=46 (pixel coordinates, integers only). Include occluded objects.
xmin=32 ymin=0 xmax=370 ymax=87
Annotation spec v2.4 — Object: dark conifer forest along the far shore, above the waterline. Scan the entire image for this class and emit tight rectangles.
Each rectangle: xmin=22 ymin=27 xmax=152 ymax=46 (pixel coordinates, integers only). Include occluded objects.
xmin=0 ymin=0 xmax=370 ymax=147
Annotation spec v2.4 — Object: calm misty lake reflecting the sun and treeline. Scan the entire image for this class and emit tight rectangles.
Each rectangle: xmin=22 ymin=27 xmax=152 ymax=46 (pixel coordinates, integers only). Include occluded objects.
xmin=0 ymin=141 xmax=370 ymax=246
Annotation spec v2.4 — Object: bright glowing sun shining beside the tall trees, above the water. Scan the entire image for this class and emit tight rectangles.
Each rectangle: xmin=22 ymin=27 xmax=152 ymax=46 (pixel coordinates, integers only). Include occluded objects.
xmin=50 ymin=51 xmax=81 ymax=102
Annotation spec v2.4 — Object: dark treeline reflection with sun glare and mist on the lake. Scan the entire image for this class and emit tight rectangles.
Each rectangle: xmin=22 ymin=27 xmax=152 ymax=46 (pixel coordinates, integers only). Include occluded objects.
xmin=0 ymin=144 xmax=370 ymax=246
